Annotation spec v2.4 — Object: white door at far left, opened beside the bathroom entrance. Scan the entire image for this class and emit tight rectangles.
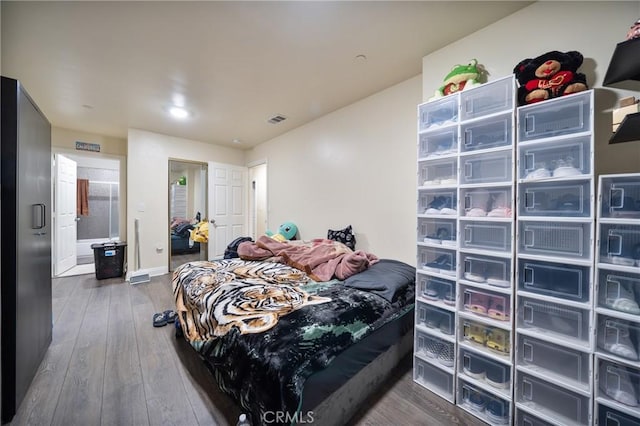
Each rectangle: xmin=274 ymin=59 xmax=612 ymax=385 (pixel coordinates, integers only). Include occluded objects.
xmin=54 ymin=154 xmax=78 ymax=275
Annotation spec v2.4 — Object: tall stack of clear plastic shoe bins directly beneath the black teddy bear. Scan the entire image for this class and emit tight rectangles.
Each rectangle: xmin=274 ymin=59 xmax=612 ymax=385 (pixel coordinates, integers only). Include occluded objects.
xmin=514 ymin=90 xmax=595 ymax=425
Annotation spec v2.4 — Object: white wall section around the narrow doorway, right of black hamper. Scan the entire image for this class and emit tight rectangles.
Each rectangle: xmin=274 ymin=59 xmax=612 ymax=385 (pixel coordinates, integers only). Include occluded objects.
xmin=127 ymin=129 xmax=245 ymax=275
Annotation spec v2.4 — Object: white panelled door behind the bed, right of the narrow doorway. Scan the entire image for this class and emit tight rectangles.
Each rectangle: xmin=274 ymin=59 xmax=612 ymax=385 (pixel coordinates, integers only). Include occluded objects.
xmin=207 ymin=161 xmax=248 ymax=259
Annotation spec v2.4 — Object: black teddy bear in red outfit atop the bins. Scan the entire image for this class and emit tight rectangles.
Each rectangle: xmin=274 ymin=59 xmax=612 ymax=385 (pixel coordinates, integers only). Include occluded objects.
xmin=513 ymin=50 xmax=588 ymax=105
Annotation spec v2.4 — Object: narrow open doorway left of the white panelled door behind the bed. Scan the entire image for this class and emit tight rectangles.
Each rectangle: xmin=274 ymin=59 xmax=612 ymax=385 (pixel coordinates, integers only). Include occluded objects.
xmin=169 ymin=159 xmax=208 ymax=271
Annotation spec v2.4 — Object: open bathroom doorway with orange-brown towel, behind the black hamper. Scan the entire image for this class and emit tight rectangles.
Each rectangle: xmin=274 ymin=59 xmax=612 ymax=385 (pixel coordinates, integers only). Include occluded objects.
xmin=52 ymin=151 xmax=124 ymax=276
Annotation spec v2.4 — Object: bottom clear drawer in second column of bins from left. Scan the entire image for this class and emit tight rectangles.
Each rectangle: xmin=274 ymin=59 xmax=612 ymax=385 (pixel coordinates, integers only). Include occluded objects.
xmin=458 ymin=381 xmax=511 ymax=426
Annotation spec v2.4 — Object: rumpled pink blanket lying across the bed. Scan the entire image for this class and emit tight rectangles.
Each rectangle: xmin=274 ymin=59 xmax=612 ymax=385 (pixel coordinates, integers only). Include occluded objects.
xmin=238 ymin=235 xmax=378 ymax=281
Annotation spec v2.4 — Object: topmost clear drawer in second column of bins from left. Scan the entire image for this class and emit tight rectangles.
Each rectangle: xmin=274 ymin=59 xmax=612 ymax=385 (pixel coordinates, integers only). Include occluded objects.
xmin=460 ymin=76 xmax=515 ymax=120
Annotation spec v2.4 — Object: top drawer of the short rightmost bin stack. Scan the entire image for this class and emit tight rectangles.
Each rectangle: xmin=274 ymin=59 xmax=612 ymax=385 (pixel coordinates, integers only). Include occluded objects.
xmin=599 ymin=174 xmax=640 ymax=219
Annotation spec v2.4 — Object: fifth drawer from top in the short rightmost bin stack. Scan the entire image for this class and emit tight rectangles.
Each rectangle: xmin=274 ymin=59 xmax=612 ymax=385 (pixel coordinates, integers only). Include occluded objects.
xmin=596 ymin=358 xmax=640 ymax=416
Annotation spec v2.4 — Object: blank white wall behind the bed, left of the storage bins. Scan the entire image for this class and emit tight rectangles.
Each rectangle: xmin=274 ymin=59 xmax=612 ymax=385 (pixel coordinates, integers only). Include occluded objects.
xmin=247 ymin=76 xmax=421 ymax=265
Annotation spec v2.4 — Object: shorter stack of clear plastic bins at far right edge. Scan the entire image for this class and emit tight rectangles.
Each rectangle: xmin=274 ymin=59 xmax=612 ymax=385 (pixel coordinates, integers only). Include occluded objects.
xmin=595 ymin=174 xmax=640 ymax=426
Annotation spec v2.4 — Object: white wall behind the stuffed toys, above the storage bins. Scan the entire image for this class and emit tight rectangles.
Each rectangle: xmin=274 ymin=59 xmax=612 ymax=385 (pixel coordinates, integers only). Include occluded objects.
xmin=422 ymin=0 xmax=640 ymax=174
